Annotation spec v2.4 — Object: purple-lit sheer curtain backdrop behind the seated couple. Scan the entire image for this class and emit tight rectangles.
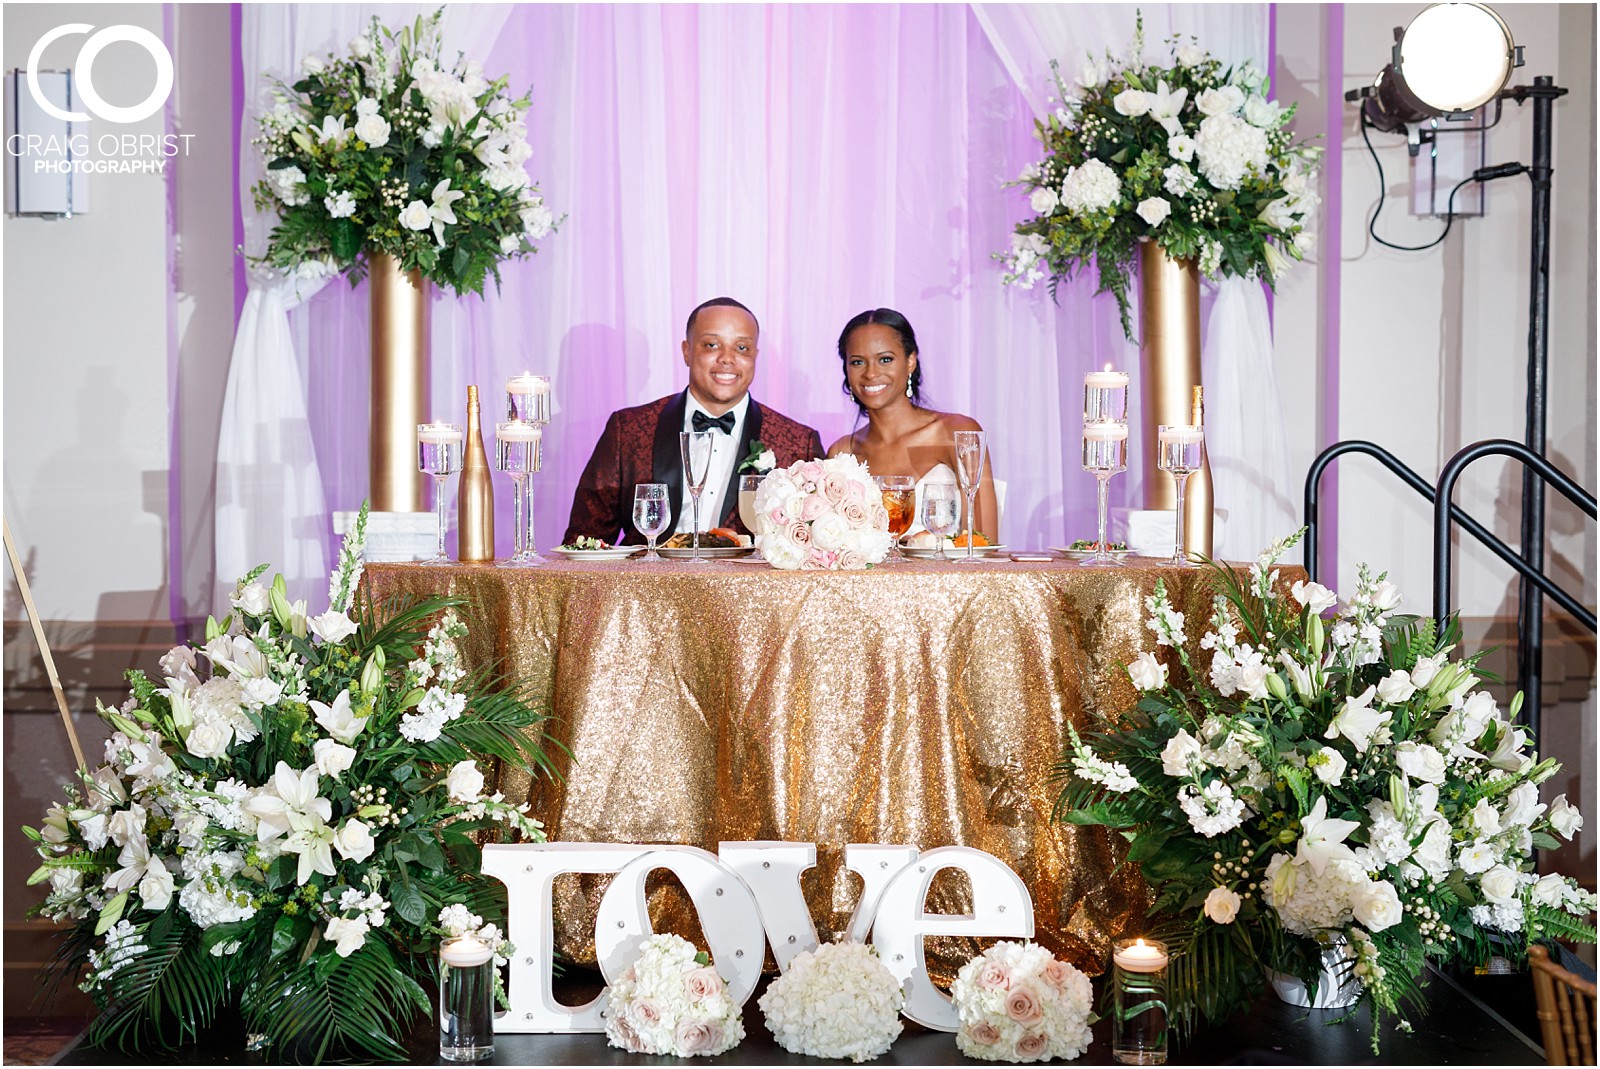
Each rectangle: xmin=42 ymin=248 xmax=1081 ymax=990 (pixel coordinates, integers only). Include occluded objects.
xmin=219 ymin=5 xmax=1266 ymax=604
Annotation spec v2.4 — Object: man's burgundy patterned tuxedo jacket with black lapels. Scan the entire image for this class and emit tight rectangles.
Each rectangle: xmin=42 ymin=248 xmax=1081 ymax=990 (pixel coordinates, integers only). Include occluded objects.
xmin=562 ymin=390 xmax=822 ymax=546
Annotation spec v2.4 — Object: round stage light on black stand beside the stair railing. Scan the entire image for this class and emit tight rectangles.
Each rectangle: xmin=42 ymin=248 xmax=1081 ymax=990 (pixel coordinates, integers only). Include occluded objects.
xmin=1346 ymin=3 xmax=1566 ymax=742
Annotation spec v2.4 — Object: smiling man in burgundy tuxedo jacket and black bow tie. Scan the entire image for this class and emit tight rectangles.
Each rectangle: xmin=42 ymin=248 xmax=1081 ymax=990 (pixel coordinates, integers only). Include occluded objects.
xmin=563 ymin=298 xmax=822 ymax=546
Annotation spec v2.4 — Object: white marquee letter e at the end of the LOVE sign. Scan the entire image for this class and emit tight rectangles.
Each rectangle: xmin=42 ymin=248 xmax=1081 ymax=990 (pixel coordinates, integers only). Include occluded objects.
xmin=872 ymin=847 xmax=1034 ymax=1032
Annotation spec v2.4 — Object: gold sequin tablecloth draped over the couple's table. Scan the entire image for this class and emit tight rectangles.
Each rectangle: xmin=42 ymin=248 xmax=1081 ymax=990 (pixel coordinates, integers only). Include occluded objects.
xmin=365 ymin=560 xmax=1273 ymax=975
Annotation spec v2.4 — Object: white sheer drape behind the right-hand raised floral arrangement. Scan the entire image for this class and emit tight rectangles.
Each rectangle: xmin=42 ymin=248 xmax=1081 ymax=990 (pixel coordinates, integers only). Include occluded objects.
xmin=973 ymin=3 xmax=1296 ymax=560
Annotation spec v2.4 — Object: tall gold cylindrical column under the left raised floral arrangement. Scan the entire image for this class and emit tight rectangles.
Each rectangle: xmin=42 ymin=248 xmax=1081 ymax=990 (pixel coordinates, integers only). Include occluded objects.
xmin=366 ymin=253 xmax=429 ymax=512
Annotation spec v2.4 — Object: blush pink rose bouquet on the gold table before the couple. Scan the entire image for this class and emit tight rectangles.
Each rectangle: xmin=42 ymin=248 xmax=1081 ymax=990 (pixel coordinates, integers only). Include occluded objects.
xmin=755 ymin=453 xmax=890 ymax=571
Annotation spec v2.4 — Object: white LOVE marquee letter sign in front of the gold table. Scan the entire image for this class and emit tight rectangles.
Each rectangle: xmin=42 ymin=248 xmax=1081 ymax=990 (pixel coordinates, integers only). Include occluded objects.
xmin=483 ymin=842 xmax=1034 ymax=1032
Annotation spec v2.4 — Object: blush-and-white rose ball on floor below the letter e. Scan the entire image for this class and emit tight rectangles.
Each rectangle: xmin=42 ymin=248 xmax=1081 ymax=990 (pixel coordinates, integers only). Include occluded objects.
xmin=950 ymin=941 xmax=1094 ymax=1061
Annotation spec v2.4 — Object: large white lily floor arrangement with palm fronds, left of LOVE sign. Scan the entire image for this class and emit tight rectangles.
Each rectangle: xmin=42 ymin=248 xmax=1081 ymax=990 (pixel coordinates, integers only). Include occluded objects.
xmin=24 ymin=506 xmax=563 ymax=1061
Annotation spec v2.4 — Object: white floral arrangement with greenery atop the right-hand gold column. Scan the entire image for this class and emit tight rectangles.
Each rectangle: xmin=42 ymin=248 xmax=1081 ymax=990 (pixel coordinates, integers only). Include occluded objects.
xmin=995 ymin=18 xmax=1320 ymax=339
